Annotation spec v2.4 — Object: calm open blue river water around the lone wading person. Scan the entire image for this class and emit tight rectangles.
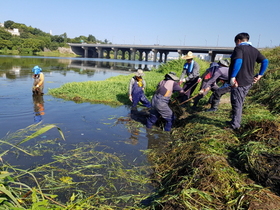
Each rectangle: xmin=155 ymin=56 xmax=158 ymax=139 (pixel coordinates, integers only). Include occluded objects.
xmin=0 ymin=56 xmax=166 ymax=168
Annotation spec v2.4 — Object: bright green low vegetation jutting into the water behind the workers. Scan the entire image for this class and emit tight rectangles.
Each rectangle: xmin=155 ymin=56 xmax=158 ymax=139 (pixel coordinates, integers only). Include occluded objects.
xmin=48 ymin=59 xmax=209 ymax=106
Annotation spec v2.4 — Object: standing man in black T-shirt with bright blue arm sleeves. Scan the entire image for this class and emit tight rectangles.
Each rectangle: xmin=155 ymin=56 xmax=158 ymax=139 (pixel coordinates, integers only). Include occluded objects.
xmin=228 ymin=33 xmax=268 ymax=130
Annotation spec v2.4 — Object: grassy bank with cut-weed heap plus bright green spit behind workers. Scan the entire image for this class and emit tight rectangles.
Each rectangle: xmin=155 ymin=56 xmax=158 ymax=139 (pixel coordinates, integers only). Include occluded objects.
xmin=47 ymin=48 xmax=280 ymax=210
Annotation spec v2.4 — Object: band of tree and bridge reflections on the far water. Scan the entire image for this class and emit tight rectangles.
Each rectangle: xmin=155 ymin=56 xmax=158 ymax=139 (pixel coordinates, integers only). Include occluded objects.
xmin=0 ymin=55 xmax=159 ymax=79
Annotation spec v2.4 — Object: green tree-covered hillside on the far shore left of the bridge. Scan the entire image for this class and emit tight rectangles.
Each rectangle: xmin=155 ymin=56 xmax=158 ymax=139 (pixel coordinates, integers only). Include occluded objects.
xmin=0 ymin=20 xmax=110 ymax=54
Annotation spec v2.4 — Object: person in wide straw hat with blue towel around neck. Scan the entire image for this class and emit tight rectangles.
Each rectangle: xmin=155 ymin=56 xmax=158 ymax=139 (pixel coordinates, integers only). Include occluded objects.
xmin=179 ymin=51 xmax=201 ymax=102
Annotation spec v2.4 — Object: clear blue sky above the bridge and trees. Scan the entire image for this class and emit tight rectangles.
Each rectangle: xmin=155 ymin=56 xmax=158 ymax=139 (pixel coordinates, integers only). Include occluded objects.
xmin=0 ymin=0 xmax=280 ymax=47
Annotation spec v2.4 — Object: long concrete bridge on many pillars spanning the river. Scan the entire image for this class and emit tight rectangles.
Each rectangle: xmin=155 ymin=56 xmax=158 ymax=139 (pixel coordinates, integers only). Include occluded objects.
xmin=68 ymin=43 xmax=234 ymax=62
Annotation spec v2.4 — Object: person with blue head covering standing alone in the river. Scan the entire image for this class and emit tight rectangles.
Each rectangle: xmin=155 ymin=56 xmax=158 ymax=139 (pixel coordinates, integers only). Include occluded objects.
xmin=32 ymin=66 xmax=45 ymax=95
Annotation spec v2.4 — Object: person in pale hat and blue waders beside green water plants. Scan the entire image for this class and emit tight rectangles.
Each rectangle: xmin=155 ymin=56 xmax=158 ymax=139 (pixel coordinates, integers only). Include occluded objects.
xmin=128 ymin=69 xmax=151 ymax=108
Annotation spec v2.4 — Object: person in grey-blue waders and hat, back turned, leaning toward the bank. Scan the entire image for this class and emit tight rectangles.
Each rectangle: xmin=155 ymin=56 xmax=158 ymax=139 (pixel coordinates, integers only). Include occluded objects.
xmin=146 ymin=72 xmax=184 ymax=131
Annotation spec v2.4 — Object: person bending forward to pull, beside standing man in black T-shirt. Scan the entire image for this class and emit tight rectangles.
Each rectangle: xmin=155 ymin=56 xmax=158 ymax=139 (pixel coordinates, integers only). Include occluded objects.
xmin=193 ymin=59 xmax=230 ymax=111
